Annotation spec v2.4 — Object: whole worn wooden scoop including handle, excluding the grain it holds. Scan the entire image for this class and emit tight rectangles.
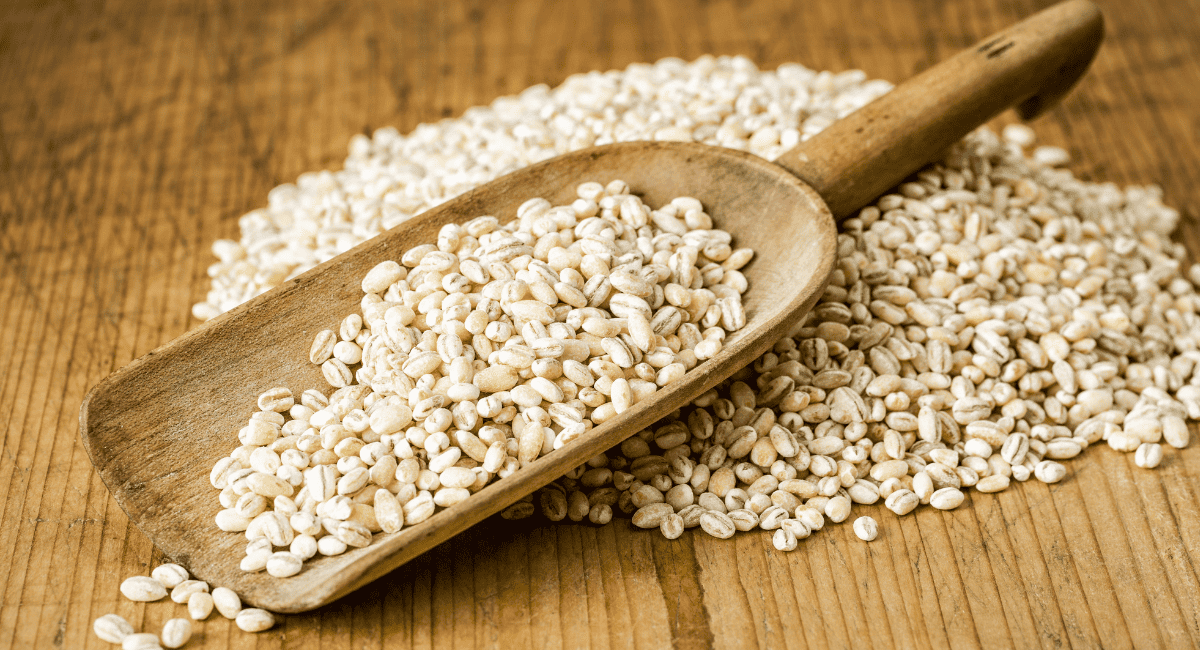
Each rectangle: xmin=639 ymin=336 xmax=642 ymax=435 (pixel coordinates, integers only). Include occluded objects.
xmin=79 ymin=0 xmax=1103 ymax=612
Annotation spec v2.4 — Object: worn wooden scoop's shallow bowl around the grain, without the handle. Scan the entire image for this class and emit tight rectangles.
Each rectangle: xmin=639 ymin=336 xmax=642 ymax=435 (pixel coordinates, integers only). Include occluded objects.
xmin=80 ymin=143 xmax=836 ymax=612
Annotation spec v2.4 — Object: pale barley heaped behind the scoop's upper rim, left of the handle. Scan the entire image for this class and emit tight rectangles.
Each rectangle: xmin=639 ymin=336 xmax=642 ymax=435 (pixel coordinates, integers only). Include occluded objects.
xmin=192 ymin=56 xmax=892 ymax=320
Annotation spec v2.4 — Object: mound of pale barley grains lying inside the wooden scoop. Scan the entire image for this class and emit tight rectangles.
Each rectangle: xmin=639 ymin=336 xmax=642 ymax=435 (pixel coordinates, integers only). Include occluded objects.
xmin=210 ymin=180 xmax=752 ymax=578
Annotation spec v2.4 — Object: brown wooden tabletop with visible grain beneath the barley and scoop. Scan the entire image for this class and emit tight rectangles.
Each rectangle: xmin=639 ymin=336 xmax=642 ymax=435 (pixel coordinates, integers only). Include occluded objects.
xmin=0 ymin=0 xmax=1200 ymax=649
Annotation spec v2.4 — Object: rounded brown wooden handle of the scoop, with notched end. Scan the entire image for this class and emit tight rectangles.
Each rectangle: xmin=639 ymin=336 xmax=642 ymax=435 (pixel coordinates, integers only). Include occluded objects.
xmin=775 ymin=0 xmax=1104 ymax=221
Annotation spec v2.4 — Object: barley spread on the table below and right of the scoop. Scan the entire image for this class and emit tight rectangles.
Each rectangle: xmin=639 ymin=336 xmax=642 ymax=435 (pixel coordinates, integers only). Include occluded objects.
xmin=518 ymin=126 xmax=1200 ymax=549
